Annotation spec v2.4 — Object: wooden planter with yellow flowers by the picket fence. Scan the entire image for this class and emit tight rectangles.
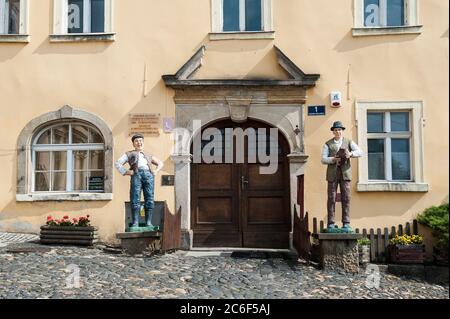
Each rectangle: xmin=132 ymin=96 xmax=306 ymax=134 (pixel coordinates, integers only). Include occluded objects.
xmin=388 ymin=235 xmax=425 ymax=264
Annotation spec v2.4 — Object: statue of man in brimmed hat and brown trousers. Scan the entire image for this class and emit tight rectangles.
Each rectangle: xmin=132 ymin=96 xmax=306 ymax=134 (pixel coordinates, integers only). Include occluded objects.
xmin=322 ymin=121 xmax=363 ymax=231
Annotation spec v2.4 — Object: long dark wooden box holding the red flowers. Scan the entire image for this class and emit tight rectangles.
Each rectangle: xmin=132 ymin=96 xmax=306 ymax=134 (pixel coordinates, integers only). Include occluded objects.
xmin=40 ymin=225 xmax=98 ymax=246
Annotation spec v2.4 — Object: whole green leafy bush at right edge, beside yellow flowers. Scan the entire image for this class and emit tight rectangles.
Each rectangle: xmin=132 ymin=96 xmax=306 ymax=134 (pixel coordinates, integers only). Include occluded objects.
xmin=417 ymin=203 xmax=448 ymax=266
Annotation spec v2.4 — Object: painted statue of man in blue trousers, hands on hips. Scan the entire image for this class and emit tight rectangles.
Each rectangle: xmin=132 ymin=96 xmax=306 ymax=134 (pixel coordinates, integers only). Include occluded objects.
xmin=115 ymin=134 xmax=163 ymax=231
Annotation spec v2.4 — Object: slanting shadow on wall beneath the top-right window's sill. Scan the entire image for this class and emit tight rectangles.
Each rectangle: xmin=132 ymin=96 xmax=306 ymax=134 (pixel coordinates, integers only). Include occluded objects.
xmin=334 ymin=30 xmax=420 ymax=52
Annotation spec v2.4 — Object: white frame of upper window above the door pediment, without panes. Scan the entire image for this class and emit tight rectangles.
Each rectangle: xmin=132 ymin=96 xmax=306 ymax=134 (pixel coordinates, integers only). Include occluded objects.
xmin=210 ymin=0 xmax=274 ymax=40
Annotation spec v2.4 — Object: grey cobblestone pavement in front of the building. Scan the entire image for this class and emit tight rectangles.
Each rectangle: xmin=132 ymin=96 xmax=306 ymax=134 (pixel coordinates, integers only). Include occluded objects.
xmin=0 ymin=243 xmax=449 ymax=299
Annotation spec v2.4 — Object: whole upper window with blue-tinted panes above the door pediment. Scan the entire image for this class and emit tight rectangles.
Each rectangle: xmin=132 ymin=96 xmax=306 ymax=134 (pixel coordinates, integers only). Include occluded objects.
xmin=211 ymin=0 xmax=273 ymax=40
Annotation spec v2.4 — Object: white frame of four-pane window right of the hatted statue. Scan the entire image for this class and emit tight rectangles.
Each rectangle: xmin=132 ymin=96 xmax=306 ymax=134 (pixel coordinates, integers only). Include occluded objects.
xmin=355 ymin=101 xmax=428 ymax=192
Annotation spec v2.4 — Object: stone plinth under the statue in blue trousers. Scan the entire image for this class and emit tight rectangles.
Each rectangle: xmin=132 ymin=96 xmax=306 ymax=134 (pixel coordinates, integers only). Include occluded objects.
xmin=116 ymin=231 xmax=162 ymax=255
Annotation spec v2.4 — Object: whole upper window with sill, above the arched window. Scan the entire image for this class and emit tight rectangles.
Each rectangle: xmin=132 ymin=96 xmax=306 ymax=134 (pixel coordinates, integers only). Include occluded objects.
xmin=50 ymin=0 xmax=114 ymax=42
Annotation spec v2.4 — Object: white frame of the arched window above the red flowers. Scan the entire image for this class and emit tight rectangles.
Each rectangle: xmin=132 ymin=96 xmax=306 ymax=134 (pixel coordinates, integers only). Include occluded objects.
xmin=31 ymin=122 xmax=105 ymax=194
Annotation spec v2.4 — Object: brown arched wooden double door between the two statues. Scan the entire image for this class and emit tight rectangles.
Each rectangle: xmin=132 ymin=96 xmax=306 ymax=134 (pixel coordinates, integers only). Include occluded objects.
xmin=191 ymin=120 xmax=291 ymax=248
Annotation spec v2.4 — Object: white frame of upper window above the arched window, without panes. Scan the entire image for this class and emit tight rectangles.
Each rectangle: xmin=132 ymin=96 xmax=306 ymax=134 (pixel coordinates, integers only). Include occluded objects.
xmin=53 ymin=0 xmax=114 ymax=35
